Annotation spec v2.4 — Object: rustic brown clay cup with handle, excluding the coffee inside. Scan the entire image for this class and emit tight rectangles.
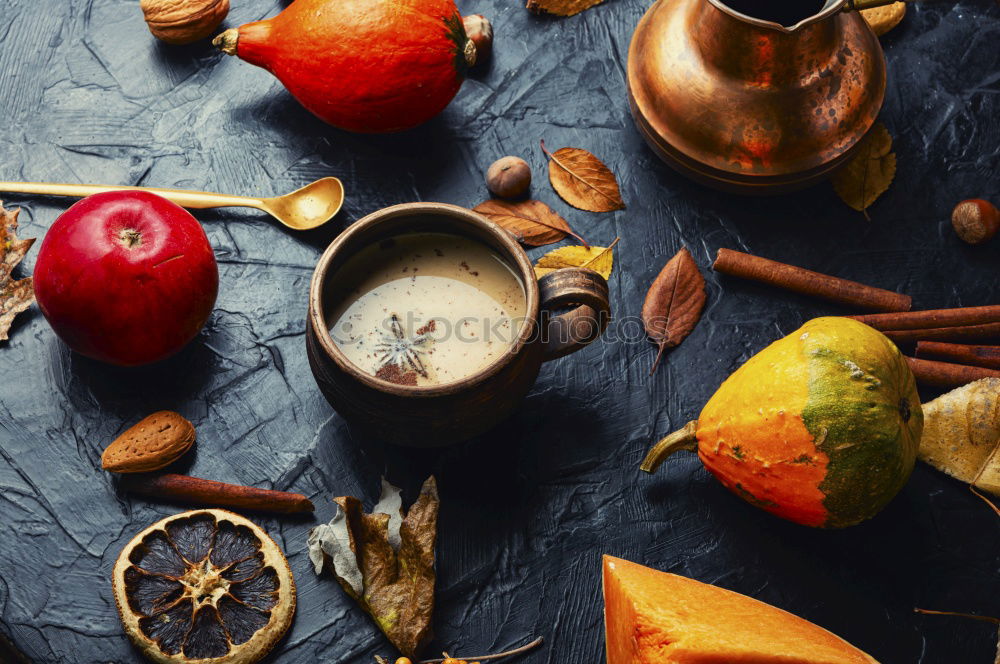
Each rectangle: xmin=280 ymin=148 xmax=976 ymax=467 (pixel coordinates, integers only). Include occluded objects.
xmin=306 ymin=203 xmax=610 ymax=447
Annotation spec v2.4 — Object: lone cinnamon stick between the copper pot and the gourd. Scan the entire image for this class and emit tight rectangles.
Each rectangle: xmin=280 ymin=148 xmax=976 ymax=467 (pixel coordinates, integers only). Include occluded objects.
xmin=712 ymin=249 xmax=912 ymax=311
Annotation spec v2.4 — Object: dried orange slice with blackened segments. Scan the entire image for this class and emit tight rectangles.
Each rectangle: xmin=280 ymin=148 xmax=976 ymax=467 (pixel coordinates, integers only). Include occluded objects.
xmin=112 ymin=509 xmax=295 ymax=664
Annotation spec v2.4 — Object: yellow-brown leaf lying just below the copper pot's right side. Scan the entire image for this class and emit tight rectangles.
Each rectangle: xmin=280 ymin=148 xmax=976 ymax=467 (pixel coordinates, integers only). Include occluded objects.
xmin=833 ymin=122 xmax=896 ymax=219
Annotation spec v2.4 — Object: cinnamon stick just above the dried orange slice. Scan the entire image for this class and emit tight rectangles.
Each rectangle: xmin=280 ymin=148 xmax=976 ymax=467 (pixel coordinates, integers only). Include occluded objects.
xmin=123 ymin=473 xmax=313 ymax=514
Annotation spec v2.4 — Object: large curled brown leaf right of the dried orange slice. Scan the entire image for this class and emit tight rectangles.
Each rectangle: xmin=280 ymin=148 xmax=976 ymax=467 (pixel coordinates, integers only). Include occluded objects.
xmin=308 ymin=477 xmax=439 ymax=658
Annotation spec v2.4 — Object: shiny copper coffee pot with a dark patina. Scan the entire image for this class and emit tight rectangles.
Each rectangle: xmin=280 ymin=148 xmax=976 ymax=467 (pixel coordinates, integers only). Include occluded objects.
xmin=628 ymin=0 xmax=887 ymax=194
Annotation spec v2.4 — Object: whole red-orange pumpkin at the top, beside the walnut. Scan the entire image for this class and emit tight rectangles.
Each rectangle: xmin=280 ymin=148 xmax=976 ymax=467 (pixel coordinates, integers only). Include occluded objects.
xmin=213 ymin=0 xmax=476 ymax=133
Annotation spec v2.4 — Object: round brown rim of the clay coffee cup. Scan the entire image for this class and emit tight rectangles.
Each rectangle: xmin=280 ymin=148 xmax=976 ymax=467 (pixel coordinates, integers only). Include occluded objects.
xmin=309 ymin=203 xmax=539 ymax=397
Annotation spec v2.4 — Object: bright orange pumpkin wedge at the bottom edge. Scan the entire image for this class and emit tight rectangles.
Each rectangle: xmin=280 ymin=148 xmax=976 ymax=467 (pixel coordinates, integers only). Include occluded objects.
xmin=604 ymin=556 xmax=878 ymax=664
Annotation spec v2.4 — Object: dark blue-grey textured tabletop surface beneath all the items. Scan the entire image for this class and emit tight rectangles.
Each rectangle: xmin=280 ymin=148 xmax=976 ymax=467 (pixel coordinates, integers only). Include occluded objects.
xmin=0 ymin=0 xmax=1000 ymax=664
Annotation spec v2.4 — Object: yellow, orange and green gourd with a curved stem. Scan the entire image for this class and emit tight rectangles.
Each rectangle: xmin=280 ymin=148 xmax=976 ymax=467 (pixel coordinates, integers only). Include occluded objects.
xmin=642 ymin=317 xmax=923 ymax=528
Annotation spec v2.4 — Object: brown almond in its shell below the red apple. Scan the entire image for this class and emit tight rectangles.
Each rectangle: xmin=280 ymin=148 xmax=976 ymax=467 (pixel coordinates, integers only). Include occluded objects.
xmin=101 ymin=410 xmax=195 ymax=473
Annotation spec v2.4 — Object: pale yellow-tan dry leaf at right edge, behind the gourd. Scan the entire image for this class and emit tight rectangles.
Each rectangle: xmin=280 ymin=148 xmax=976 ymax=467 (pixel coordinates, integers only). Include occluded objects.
xmin=917 ymin=378 xmax=1000 ymax=496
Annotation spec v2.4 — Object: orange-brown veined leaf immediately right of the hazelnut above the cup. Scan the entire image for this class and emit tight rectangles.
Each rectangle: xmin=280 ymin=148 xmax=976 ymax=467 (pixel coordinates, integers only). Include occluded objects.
xmin=541 ymin=141 xmax=625 ymax=212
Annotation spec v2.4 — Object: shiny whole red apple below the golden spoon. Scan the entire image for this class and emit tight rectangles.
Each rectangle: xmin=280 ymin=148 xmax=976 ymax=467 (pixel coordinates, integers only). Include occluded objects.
xmin=34 ymin=191 xmax=219 ymax=366
